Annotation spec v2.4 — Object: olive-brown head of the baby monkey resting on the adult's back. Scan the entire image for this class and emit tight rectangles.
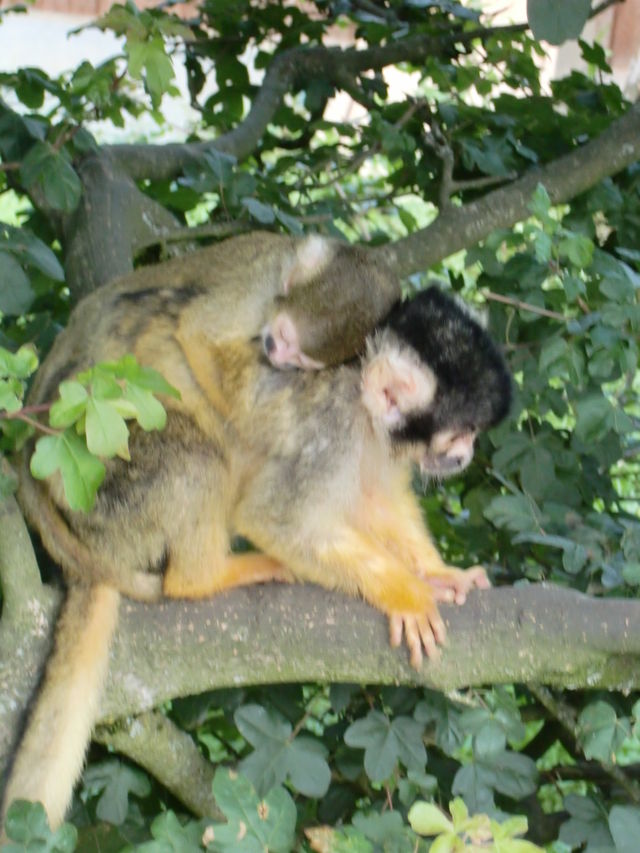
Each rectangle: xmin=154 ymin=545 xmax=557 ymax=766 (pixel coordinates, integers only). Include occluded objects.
xmin=262 ymin=236 xmax=400 ymax=370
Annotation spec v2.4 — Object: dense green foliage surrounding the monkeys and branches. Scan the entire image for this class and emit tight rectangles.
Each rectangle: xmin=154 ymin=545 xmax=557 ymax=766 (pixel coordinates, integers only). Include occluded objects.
xmin=0 ymin=0 xmax=640 ymax=853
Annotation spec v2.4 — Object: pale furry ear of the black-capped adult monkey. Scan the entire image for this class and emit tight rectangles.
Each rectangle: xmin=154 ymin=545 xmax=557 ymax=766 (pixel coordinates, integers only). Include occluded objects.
xmin=362 ymin=335 xmax=438 ymax=430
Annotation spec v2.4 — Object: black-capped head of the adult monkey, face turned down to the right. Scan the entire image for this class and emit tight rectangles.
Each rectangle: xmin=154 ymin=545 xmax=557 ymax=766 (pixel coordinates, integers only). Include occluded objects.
xmin=362 ymin=287 xmax=511 ymax=477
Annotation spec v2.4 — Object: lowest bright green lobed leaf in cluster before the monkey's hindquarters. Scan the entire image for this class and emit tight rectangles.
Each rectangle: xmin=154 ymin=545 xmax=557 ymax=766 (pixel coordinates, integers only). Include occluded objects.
xmin=30 ymin=430 xmax=105 ymax=512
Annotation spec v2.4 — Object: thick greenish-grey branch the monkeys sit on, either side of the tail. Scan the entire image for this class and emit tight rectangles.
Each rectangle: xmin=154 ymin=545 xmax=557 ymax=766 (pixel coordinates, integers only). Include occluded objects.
xmin=0 ymin=500 xmax=640 ymax=766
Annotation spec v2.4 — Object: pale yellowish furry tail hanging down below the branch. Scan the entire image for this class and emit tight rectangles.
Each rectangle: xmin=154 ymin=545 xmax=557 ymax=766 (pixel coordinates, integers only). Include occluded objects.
xmin=0 ymin=585 xmax=120 ymax=827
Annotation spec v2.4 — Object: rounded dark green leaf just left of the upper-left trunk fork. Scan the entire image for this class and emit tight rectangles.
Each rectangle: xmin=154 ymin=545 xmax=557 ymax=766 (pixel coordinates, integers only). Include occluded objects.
xmin=20 ymin=142 xmax=82 ymax=213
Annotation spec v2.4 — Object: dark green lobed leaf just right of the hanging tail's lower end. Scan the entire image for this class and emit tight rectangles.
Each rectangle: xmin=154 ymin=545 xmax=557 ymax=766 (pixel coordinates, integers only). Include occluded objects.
xmin=83 ymin=760 xmax=151 ymax=826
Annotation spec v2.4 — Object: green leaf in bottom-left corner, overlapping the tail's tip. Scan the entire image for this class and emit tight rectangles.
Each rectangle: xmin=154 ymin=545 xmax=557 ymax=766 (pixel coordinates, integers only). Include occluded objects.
xmin=2 ymin=800 xmax=78 ymax=853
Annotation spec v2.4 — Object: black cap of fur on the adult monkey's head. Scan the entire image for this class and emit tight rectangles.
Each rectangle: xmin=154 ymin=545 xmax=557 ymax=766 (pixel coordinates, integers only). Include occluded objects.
xmin=384 ymin=287 xmax=511 ymax=441
